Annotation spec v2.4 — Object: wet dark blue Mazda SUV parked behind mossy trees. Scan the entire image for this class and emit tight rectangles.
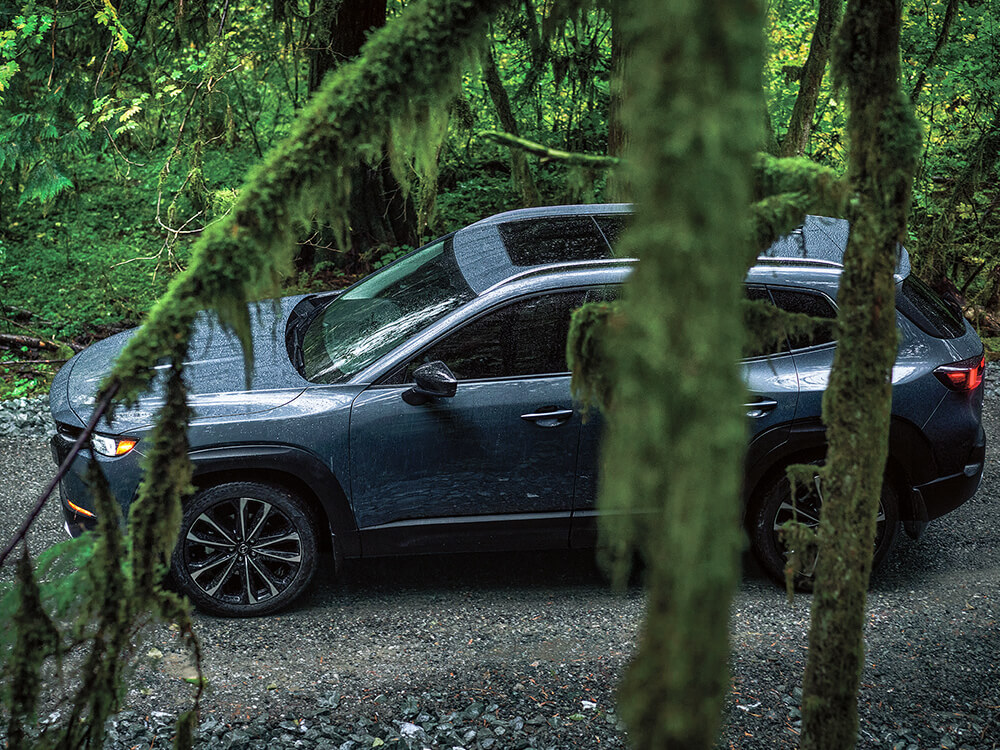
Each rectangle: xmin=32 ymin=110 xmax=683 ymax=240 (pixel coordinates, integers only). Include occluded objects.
xmin=50 ymin=205 xmax=985 ymax=615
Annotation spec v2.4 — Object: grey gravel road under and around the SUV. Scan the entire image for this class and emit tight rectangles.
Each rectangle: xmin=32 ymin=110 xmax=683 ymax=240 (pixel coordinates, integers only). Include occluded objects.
xmin=0 ymin=388 xmax=1000 ymax=750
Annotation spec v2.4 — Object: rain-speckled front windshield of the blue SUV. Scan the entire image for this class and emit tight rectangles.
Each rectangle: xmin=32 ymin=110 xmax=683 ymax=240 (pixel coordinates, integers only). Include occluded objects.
xmin=302 ymin=237 xmax=476 ymax=383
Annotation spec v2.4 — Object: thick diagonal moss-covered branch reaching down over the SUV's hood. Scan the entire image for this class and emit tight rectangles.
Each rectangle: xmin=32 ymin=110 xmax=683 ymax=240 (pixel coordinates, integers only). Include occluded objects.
xmin=103 ymin=0 xmax=503 ymax=408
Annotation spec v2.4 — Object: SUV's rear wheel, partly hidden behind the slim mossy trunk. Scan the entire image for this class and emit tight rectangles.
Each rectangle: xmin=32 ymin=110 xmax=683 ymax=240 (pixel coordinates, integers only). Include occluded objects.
xmin=750 ymin=471 xmax=899 ymax=591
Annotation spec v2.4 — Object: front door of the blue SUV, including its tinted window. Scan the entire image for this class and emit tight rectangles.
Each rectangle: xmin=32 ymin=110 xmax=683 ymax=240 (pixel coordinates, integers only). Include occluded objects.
xmin=350 ymin=292 xmax=583 ymax=555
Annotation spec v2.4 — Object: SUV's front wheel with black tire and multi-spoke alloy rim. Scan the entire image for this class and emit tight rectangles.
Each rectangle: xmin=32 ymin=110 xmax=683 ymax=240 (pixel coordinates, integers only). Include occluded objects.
xmin=170 ymin=482 xmax=318 ymax=617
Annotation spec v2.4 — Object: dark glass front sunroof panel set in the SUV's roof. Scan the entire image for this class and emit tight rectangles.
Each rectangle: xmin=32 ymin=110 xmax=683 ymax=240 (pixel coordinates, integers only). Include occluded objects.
xmin=497 ymin=216 xmax=611 ymax=266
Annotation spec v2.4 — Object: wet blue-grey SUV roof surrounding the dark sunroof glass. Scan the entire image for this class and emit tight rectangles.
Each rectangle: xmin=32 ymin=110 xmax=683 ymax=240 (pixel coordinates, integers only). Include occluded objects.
xmin=453 ymin=209 xmax=910 ymax=294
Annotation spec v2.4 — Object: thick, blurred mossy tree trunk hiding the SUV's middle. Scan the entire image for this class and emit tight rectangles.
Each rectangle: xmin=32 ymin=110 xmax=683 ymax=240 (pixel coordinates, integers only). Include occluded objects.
xmin=600 ymin=0 xmax=763 ymax=750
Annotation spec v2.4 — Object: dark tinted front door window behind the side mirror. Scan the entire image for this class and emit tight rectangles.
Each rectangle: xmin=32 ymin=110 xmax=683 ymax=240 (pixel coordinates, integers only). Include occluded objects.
xmin=405 ymin=292 xmax=584 ymax=382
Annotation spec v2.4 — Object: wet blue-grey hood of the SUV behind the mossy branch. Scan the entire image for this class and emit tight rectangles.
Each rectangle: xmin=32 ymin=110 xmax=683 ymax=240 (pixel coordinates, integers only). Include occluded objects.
xmin=50 ymin=297 xmax=310 ymax=434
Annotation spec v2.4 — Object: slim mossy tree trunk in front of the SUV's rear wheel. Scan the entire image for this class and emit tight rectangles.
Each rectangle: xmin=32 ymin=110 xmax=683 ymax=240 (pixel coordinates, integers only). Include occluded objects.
xmin=800 ymin=0 xmax=920 ymax=750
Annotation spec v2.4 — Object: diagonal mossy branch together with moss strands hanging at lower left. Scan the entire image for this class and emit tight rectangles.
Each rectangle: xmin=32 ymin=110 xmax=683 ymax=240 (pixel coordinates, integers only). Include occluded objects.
xmin=0 ymin=0 xmax=503 ymax=750
